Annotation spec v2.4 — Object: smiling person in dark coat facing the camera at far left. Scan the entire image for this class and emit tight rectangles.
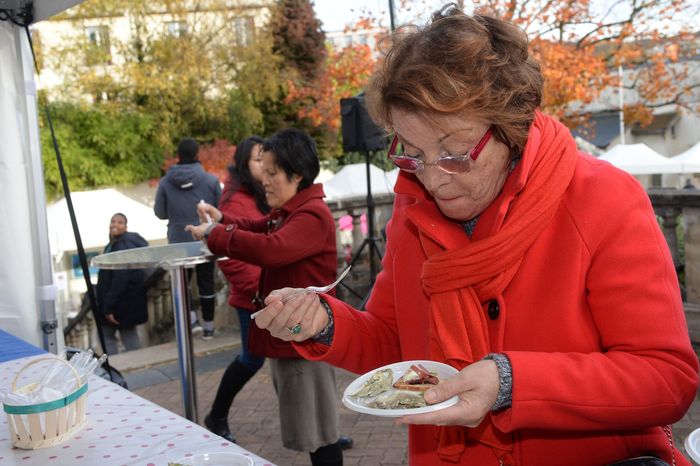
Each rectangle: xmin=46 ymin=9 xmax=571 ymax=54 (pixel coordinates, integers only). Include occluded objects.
xmin=96 ymin=213 xmax=148 ymax=354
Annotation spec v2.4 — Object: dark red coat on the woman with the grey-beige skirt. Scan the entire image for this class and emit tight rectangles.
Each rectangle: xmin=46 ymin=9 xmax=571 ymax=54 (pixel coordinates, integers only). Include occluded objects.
xmin=207 ymin=184 xmax=338 ymax=358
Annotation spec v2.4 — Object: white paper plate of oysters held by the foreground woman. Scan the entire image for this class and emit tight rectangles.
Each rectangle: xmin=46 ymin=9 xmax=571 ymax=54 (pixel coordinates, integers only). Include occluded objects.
xmin=343 ymin=361 xmax=459 ymax=417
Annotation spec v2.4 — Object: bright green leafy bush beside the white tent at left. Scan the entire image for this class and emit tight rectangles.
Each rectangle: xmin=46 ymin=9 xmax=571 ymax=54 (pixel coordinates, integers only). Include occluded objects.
xmin=41 ymin=103 xmax=163 ymax=198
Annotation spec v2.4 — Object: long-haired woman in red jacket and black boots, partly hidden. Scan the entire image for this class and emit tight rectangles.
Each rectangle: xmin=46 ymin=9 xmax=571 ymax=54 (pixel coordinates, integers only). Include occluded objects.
xmin=204 ymin=136 xmax=270 ymax=442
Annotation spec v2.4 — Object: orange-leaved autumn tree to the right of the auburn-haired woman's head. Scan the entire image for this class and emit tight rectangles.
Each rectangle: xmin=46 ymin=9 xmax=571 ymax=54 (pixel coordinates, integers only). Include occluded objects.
xmin=456 ymin=0 xmax=700 ymax=127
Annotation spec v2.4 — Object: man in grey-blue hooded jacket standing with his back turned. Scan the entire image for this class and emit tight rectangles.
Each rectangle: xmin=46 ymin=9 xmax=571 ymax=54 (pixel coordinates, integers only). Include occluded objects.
xmin=153 ymin=138 xmax=221 ymax=340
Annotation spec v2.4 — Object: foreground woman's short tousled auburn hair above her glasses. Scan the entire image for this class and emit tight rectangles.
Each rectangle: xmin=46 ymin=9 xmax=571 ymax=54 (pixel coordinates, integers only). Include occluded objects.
xmin=365 ymin=4 xmax=544 ymax=158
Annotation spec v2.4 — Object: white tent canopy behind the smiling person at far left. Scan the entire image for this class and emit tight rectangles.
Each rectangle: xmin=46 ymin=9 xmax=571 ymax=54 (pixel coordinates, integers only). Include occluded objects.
xmin=47 ymin=189 xmax=167 ymax=255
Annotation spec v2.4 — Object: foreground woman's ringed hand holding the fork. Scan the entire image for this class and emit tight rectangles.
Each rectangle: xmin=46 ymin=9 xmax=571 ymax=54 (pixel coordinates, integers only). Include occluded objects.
xmin=254 ymin=288 xmax=328 ymax=341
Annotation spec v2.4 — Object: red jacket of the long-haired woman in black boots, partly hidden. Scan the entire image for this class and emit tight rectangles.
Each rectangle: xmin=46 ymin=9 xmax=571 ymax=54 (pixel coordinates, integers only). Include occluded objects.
xmin=217 ymin=186 xmax=265 ymax=309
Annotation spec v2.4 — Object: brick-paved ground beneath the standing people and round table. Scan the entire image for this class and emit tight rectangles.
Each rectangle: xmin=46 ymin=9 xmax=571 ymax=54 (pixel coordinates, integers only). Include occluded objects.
xmin=116 ymin=332 xmax=700 ymax=466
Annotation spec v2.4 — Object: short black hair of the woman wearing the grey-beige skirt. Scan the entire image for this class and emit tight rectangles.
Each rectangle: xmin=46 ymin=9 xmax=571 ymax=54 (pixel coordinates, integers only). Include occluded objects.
xmin=263 ymin=128 xmax=321 ymax=191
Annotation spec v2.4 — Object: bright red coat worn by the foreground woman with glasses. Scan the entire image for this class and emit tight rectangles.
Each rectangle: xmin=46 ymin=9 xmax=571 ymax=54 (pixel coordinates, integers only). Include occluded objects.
xmin=295 ymin=154 xmax=698 ymax=466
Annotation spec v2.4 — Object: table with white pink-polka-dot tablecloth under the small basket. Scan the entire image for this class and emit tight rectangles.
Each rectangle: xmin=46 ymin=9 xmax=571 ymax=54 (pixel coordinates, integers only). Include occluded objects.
xmin=0 ymin=357 xmax=274 ymax=466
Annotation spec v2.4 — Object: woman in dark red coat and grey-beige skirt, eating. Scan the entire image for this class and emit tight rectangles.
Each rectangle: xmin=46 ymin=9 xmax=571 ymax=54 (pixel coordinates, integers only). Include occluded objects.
xmin=187 ymin=129 xmax=343 ymax=466
